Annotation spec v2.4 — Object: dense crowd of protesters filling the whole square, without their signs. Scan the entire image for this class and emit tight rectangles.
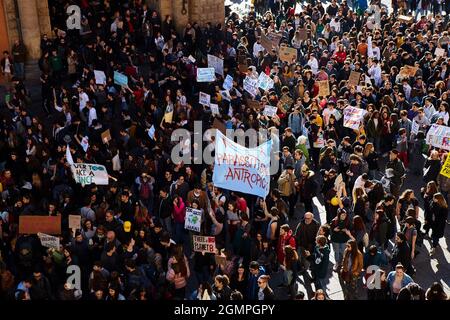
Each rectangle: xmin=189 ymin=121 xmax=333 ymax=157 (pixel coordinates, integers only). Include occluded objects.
xmin=0 ymin=0 xmax=450 ymax=301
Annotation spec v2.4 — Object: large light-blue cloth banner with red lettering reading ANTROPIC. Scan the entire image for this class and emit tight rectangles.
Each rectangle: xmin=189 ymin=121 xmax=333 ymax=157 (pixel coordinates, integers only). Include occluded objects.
xmin=213 ymin=132 xmax=272 ymax=198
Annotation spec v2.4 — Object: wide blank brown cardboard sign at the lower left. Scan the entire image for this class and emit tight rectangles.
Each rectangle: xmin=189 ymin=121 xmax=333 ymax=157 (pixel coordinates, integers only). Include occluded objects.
xmin=19 ymin=216 xmax=61 ymax=234
